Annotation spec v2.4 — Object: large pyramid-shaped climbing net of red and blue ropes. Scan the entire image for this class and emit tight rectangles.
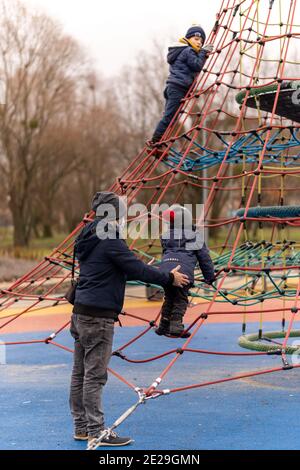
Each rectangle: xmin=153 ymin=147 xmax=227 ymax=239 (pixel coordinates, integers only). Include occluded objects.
xmin=0 ymin=0 xmax=300 ymax=404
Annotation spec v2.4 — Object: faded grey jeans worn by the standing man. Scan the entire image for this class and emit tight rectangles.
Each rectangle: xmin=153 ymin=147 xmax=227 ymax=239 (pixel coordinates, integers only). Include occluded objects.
xmin=70 ymin=314 xmax=114 ymax=437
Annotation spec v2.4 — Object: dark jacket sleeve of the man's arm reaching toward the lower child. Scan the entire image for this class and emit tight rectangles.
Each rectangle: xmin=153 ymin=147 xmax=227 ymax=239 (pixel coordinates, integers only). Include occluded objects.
xmin=107 ymin=239 xmax=174 ymax=287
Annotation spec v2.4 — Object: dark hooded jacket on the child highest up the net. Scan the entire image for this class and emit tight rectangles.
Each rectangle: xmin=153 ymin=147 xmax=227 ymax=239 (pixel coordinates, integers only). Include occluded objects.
xmin=167 ymin=42 xmax=207 ymax=90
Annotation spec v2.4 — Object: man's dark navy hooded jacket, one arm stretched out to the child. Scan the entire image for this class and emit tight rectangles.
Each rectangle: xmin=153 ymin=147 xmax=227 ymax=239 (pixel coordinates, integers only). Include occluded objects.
xmin=73 ymin=219 xmax=174 ymax=319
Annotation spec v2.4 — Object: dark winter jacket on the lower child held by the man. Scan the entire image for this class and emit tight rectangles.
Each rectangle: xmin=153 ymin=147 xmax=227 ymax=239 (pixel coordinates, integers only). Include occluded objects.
xmin=159 ymin=227 xmax=215 ymax=284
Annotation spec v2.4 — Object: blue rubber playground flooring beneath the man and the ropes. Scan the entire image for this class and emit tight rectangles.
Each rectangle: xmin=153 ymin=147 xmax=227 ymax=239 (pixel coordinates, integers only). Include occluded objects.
xmin=0 ymin=324 xmax=300 ymax=450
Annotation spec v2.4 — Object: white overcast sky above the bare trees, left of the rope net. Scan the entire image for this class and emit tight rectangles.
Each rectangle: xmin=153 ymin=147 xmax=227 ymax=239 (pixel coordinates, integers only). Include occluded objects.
xmin=23 ymin=0 xmax=221 ymax=76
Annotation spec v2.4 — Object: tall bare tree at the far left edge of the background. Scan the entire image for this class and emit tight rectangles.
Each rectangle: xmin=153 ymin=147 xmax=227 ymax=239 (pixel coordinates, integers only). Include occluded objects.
xmin=0 ymin=0 xmax=84 ymax=246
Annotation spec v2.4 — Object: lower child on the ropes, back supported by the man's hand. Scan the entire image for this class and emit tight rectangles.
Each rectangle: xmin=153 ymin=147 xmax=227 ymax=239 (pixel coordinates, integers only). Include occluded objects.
xmin=155 ymin=204 xmax=215 ymax=337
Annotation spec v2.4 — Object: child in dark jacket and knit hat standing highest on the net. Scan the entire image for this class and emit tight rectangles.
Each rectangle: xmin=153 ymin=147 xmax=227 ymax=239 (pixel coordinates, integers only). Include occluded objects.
xmin=149 ymin=26 xmax=213 ymax=145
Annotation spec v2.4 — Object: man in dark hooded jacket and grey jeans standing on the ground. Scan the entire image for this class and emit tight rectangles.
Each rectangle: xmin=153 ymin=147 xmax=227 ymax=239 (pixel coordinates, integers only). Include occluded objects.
xmin=70 ymin=192 xmax=189 ymax=446
